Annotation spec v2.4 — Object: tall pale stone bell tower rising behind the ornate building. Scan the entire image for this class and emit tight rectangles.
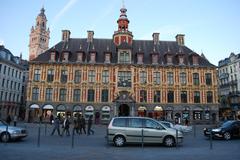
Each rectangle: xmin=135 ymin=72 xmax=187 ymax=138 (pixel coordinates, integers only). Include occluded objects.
xmin=29 ymin=8 xmax=50 ymax=61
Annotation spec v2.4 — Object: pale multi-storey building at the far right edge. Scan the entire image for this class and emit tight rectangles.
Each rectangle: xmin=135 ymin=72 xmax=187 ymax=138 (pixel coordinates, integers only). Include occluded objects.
xmin=218 ymin=53 xmax=240 ymax=119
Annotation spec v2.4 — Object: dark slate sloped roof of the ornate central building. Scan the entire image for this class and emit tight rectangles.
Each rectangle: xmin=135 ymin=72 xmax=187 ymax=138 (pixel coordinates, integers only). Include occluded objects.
xmin=32 ymin=38 xmax=215 ymax=67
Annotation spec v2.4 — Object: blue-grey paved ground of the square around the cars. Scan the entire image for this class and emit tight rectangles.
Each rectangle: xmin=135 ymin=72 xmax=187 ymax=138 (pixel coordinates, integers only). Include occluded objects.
xmin=0 ymin=123 xmax=240 ymax=160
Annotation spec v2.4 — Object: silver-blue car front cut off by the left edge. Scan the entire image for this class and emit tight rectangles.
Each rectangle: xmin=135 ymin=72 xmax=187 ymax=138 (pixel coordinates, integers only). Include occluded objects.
xmin=0 ymin=120 xmax=28 ymax=142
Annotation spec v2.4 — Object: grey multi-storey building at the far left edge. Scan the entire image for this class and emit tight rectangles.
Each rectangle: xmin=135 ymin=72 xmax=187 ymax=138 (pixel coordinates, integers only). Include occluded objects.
xmin=0 ymin=46 xmax=25 ymax=119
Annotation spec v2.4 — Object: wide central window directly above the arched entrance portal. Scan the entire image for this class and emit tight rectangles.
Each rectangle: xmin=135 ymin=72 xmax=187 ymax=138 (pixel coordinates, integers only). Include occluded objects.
xmin=118 ymin=71 xmax=132 ymax=87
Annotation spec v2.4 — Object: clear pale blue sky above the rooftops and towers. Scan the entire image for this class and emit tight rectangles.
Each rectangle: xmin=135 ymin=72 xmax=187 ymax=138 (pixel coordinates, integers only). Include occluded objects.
xmin=0 ymin=0 xmax=240 ymax=65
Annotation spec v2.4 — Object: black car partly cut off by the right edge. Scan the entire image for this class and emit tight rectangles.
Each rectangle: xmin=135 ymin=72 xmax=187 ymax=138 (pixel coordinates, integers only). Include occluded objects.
xmin=203 ymin=120 xmax=240 ymax=140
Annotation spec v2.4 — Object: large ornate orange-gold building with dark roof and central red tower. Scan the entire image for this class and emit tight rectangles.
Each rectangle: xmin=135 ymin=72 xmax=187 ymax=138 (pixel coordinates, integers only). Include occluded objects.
xmin=26 ymin=7 xmax=218 ymax=123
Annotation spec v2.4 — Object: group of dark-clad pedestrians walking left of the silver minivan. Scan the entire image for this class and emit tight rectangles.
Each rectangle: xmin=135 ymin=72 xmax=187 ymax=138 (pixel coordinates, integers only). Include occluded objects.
xmin=50 ymin=114 xmax=94 ymax=136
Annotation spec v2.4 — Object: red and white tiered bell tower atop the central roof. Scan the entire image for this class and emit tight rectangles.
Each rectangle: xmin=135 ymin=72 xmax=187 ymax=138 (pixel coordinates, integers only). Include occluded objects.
xmin=113 ymin=5 xmax=133 ymax=46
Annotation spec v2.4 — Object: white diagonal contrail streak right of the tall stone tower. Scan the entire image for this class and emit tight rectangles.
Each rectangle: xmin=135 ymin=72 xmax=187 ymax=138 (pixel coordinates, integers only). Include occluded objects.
xmin=50 ymin=0 xmax=78 ymax=29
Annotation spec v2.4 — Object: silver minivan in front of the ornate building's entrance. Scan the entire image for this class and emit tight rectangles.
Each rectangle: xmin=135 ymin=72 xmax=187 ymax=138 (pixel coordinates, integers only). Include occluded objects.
xmin=107 ymin=117 xmax=183 ymax=147
